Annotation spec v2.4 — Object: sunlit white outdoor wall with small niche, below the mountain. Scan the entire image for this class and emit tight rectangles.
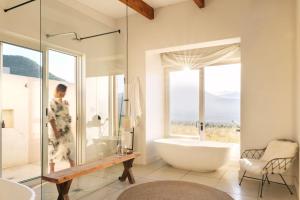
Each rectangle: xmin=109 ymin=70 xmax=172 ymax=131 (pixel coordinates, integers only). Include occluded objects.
xmin=2 ymin=74 xmax=31 ymax=168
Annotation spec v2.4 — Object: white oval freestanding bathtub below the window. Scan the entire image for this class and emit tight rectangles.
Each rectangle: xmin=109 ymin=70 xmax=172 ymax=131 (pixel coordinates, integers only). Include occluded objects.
xmin=154 ymin=139 xmax=231 ymax=172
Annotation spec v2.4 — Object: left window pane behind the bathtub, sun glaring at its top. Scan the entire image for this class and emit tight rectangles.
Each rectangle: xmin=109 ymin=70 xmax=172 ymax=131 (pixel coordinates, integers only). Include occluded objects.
xmin=169 ymin=70 xmax=199 ymax=136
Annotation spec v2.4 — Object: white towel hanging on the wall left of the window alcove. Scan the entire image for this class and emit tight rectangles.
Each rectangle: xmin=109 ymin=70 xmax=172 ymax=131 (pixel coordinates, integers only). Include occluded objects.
xmin=128 ymin=78 xmax=142 ymax=128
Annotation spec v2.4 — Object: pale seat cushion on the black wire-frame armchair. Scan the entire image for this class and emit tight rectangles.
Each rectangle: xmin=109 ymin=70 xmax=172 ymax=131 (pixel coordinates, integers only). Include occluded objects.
xmin=240 ymin=158 xmax=268 ymax=175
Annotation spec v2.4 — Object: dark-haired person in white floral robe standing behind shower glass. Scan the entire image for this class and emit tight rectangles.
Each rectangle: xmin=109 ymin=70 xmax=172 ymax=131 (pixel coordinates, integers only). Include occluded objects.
xmin=48 ymin=84 xmax=75 ymax=173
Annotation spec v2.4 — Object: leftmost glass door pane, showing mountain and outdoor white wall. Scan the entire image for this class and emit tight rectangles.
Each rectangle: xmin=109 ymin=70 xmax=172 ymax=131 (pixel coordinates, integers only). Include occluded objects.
xmin=1 ymin=43 xmax=42 ymax=181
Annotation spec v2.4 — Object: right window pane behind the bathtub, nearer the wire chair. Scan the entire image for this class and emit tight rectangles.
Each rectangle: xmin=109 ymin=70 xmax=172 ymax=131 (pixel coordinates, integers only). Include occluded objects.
xmin=205 ymin=64 xmax=241 ymax=143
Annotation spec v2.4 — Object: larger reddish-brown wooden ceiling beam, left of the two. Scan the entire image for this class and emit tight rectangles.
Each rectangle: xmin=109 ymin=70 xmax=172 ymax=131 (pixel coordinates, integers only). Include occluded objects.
xmin=119 ymin=0 xmax=154 ymax=20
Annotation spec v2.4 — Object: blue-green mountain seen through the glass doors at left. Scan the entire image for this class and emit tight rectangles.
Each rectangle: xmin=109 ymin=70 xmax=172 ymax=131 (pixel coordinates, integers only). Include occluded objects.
xmin=3 ymin=55 xmax=65 ymax=81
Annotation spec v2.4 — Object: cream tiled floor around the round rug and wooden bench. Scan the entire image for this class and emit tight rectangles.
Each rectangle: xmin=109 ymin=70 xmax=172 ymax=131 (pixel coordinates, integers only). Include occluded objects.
xmin=31 ymin=161 xmax=297 ymax=200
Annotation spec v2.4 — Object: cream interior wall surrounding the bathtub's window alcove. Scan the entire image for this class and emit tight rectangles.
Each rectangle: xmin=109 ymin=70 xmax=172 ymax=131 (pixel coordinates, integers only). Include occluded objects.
xmin=119 ymin=0 xmax=295 ymax=173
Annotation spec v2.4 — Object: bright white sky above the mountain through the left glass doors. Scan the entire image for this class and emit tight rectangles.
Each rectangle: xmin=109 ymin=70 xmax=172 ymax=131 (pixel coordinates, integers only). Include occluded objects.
xmin=3 ymin=43 xmax=76 ymax=83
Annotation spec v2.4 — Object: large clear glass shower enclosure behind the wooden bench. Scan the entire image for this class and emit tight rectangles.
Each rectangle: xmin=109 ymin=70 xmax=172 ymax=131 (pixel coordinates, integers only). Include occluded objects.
xmin=0 ymin=0 xmax=127 ymax=199
